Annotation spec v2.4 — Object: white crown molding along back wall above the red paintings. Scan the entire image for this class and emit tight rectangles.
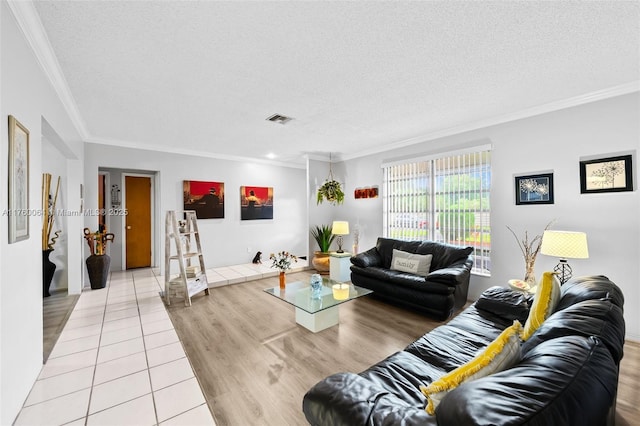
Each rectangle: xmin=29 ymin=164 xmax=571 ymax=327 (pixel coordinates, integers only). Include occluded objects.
xmin=85 ymin=137 xmax=306 ymax=169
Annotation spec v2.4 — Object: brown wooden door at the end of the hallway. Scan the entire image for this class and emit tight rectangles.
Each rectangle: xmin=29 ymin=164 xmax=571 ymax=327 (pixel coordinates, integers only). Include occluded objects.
xmin=125 ymin=176 xmax=151 ymax=269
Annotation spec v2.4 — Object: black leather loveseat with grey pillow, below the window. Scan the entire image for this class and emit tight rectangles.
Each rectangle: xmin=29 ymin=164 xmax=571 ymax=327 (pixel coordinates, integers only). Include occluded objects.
xmin=351 ymin=238 xmax=473 ymax=320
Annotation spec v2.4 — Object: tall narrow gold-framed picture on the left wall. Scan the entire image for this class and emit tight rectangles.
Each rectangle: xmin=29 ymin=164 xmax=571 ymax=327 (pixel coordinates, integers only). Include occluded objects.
xmin=9 ymin=115 xmax=29 ymax=244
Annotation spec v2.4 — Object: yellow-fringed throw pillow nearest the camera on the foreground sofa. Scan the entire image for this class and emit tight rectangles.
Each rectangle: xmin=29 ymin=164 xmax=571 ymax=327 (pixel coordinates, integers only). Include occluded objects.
xmin=420 ymin=320 xmax=522 ymax=415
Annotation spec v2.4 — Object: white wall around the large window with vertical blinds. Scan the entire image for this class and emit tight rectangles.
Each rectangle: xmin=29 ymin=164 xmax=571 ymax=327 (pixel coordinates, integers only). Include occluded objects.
xmin=341 ymin=93 xmax=640 ymax=340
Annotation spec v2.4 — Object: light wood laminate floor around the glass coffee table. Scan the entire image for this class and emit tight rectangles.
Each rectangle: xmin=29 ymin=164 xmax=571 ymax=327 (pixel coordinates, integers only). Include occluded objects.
xmin=168 ymin=272 xmax=640 ymax=426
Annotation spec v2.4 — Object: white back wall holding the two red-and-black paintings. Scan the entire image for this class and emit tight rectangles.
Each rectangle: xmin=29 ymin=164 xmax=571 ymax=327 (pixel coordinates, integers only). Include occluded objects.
xmin=85 ymin=144 xmax=308 ymax=274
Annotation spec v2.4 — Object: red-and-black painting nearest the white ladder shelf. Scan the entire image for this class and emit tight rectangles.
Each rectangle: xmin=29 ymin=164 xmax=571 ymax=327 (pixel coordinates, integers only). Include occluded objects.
xmin=182 ymin=180 xmax=224 ymax=219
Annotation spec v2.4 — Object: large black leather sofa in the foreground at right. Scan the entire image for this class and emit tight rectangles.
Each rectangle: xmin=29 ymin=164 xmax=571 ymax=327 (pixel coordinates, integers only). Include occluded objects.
xmin=303 ymin=276 xmax=625 ymax=426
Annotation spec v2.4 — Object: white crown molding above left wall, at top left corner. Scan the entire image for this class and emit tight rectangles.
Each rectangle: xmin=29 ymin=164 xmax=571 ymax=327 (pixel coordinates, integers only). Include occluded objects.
xmin=7 ymin=0 xmax=89 ymax=139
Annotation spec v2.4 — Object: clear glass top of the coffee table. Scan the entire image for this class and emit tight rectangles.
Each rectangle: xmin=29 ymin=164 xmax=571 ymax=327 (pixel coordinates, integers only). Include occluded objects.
xmin=264 ymin=277 xmax=373 ymax=314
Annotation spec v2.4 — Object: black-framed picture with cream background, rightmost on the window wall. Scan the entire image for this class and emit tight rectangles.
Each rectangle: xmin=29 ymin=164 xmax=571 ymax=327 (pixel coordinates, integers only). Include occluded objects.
xmin=580 ymin=155 xmax=633 ymax=194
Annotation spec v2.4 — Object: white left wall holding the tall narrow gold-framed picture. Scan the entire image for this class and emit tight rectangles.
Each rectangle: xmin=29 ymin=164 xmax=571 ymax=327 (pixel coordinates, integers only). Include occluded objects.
xmin=0 ymin=1 xmax=82 ymax=424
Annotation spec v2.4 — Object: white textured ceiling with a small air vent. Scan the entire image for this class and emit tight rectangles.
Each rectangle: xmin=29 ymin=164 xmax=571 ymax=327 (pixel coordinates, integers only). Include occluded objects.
xmin=34 ymin=0 xmax=640 ymax=163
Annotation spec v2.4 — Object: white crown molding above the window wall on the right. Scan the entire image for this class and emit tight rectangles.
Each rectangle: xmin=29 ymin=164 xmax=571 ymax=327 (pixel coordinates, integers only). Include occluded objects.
xmin=342 ymin=80 xmax=640 ymax=161
